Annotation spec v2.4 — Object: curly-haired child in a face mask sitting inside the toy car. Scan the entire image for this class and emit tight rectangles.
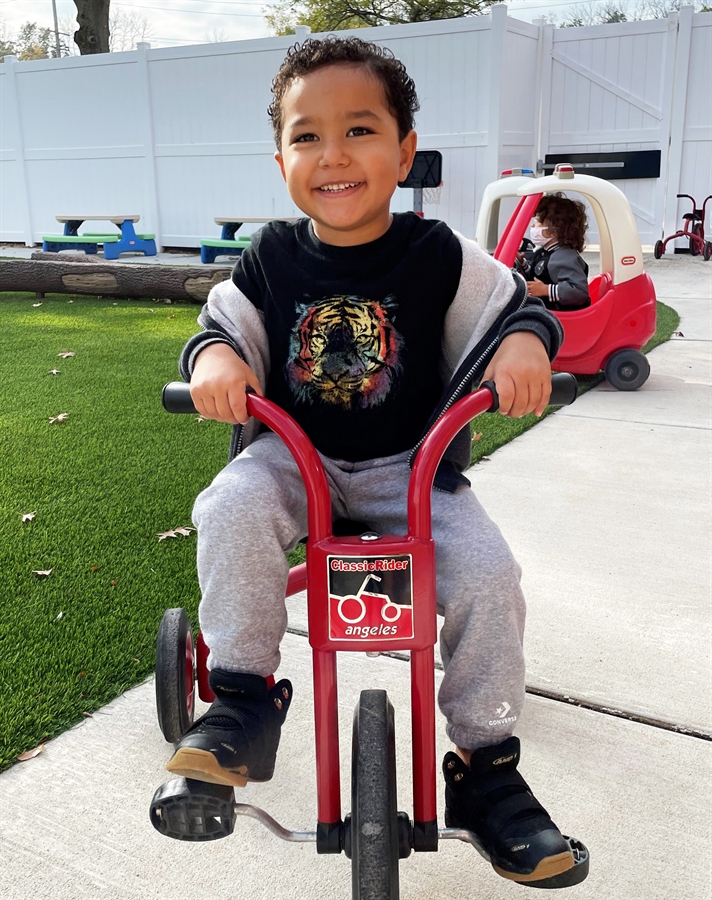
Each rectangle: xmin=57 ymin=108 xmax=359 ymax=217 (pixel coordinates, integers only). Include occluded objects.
xmin=518 ymin=194 xmax=591 ymax=311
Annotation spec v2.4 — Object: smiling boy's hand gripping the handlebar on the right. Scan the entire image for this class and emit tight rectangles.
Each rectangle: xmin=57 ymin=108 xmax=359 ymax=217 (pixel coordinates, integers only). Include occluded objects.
xmin=482 ymin=331 xmax=551 ymax=419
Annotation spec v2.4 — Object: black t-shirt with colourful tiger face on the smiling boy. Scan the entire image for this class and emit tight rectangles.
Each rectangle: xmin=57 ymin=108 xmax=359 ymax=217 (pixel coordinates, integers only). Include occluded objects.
xmin=233 ymin=213 xmax=462 ymax=462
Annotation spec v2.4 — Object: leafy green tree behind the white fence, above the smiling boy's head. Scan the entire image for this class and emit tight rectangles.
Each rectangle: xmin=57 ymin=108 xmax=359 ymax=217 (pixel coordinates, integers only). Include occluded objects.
xmin=265 ymin=0 xmax=498 ymax=34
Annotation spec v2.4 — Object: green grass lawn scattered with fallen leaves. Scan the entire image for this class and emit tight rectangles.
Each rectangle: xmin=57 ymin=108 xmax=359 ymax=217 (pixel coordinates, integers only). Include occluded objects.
xmin=0 ymin=294 xmax=677 ymax=769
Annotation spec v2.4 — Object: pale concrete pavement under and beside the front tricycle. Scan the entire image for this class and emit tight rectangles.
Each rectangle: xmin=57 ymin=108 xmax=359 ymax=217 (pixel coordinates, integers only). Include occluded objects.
xmin=0 ymin=256 xmax=712 ymax=900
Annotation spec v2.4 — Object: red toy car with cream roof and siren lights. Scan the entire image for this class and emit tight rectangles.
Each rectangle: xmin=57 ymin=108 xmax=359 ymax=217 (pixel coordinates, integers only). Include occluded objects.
xmin=476 ymin=163 xmax=656 ymax=391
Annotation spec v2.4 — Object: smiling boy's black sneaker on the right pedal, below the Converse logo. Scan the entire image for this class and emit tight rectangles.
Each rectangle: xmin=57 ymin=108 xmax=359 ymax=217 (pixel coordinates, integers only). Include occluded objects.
xmin=443 ymin=737 xmax=574 ymax=883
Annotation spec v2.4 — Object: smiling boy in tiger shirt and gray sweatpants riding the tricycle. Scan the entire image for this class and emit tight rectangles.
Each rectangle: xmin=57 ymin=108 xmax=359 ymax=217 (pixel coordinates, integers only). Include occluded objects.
xmin=167 ymin=38 xmax=573 ymax=882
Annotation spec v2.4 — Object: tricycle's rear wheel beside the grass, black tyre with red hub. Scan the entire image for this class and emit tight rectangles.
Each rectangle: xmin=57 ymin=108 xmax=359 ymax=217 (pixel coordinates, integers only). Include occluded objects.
xmin=156 ymin=608 xmax=195 ymax=744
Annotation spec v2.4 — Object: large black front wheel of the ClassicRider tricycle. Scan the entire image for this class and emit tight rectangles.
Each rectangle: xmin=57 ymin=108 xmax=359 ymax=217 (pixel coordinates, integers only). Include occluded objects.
xmin=350 ymin=691 xmax=399 ymax=900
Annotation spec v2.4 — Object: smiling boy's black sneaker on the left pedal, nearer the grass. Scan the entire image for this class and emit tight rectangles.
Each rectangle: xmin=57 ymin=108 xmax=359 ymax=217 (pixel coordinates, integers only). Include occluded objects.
xmin=166 ymin=669 xmax=292 ymax=787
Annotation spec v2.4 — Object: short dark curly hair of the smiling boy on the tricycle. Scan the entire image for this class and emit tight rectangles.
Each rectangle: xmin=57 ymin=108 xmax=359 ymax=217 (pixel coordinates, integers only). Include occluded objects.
xmin=267 ymin=37 xmax=420 ymax=149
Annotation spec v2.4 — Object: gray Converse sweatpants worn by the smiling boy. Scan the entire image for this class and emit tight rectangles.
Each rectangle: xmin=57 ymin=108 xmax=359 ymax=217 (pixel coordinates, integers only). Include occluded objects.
xmin=193 ymin=434 xmax=525 ymax=749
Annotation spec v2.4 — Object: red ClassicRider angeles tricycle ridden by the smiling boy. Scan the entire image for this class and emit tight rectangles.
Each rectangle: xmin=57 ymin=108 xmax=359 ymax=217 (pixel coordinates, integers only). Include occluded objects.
xmin=150 ymin=374 xmax=589 ymax=900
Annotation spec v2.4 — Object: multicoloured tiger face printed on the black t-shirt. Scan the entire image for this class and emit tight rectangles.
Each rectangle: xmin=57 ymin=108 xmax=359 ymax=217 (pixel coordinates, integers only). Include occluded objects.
xmin=285 ymin=295 xmax=403 ymax=409
